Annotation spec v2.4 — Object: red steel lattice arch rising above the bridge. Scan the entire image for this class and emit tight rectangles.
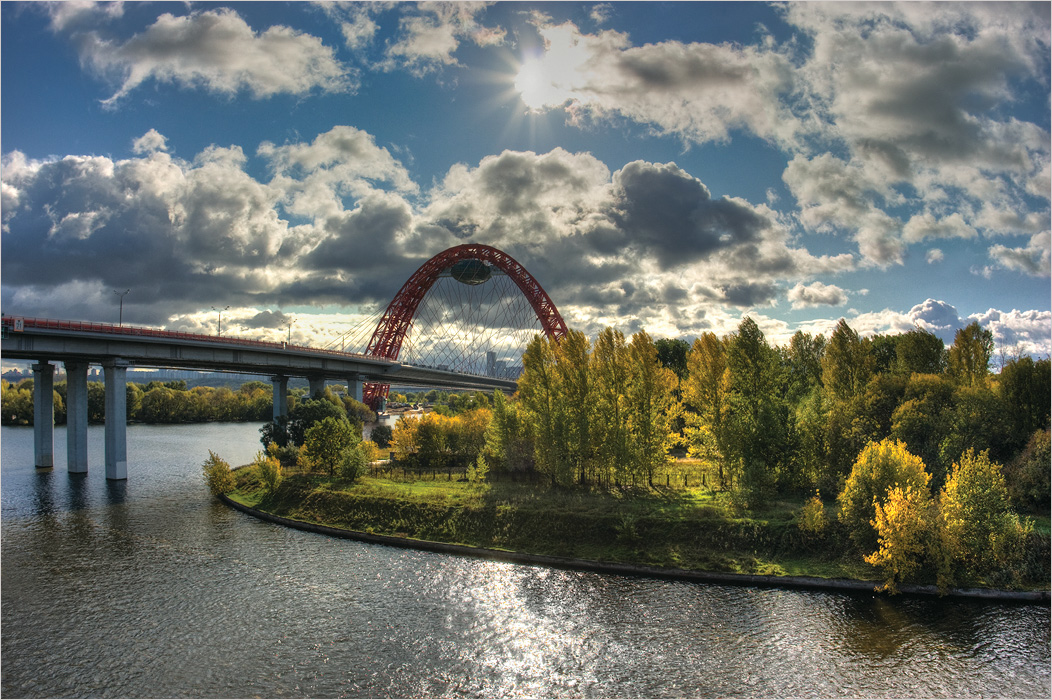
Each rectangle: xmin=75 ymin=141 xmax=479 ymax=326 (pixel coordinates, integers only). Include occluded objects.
xmin=363 ymin=243 xmax=567 ymax=408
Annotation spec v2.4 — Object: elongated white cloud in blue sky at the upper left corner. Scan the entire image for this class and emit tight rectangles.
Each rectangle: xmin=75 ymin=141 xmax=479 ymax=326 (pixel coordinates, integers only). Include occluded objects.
xmin=74 ymin=8 xmax=357 ymax=105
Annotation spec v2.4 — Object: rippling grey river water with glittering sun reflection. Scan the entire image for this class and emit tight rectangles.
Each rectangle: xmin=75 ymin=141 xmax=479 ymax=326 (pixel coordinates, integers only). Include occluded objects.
xmin=0 ymin=424 xmax=1050 ymax=698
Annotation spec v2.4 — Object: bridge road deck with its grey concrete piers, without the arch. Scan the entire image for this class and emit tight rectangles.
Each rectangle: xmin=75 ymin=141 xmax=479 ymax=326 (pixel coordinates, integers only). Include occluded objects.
xmin=0 ymin=317 xmax=515 ymax=479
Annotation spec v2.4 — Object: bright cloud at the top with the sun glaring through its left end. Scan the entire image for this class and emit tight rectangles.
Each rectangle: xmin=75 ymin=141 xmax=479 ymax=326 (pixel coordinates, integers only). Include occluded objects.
xmin=521 ymin=16 xmax=795 ymax=143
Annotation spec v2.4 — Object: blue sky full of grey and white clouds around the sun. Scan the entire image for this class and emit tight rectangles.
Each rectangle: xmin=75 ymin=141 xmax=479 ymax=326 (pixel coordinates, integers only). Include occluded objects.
xmin=0 ymin=2 xmax=1052 ymax=356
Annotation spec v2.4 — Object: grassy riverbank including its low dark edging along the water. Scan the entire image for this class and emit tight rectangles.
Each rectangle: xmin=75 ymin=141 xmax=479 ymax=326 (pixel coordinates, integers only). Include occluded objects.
xmin=223 ymin=474 xmax=1049 ymax=603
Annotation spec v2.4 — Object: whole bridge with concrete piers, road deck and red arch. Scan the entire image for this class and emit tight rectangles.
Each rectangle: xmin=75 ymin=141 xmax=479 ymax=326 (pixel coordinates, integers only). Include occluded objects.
xmin=0 ymin=244 xmax=566 ymax=479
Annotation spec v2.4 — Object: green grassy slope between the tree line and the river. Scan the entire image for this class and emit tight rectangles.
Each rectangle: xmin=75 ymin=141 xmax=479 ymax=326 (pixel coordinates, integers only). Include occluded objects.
xmin=230 ymin=469 xmax=1049 ymax=589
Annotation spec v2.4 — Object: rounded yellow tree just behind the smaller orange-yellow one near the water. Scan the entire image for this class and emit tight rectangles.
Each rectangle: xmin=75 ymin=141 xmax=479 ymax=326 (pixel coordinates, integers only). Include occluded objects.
xmin=836 ymin=439 xmax=931 ymax=552
